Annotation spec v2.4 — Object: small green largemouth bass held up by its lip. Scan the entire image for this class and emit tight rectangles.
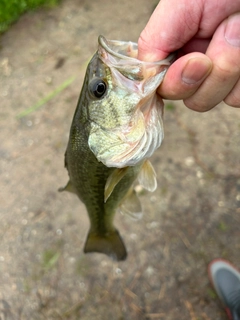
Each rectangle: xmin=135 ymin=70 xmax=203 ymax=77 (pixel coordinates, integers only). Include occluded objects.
xmin=59 ymin=36 xmax=173 ymax=261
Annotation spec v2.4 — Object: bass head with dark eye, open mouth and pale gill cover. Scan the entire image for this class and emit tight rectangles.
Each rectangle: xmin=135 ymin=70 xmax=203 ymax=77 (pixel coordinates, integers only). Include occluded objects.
xmin=87 ymin=36 xmax=173 ymax=168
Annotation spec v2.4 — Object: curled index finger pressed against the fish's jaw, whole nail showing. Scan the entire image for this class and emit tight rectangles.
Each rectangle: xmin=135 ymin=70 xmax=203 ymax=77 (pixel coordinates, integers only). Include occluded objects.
xmin=158 ymin=52 xmax=212 ymax=100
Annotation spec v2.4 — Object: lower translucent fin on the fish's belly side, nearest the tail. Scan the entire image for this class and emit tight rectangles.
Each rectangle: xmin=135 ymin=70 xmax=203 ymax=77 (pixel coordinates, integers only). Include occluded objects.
xmin=118 ymin=187 xmax=143 ymax=220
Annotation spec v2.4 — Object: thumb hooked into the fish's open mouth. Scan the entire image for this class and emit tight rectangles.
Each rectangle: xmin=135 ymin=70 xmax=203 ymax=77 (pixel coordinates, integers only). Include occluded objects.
xmin=138 ymin=0 xmax=202 ymax=61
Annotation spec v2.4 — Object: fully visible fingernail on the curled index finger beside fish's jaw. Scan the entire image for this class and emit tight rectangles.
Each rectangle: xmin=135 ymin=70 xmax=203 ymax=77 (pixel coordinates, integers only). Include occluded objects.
xmin=182 ymin=58 xmax=212 ymax=84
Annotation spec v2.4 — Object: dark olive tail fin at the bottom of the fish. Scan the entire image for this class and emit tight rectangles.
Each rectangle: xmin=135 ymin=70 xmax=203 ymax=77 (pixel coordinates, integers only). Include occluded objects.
xmin=84 ymin=230 xmax=127 ymax=261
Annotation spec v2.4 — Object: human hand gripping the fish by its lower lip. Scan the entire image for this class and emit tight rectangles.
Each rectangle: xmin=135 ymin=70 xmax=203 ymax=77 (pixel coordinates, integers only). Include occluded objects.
xmin=138 ymin=0 xmax=240 ymax=112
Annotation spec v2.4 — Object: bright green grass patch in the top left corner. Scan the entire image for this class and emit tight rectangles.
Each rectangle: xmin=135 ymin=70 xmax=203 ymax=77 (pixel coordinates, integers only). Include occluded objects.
xmin=0 ymin=0 xmax=60 ymax=33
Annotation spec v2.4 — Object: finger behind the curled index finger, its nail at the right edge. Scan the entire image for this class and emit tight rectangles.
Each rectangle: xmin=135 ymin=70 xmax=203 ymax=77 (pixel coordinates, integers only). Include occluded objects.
xmin=184 ymin=13 xmax=240 ymax=112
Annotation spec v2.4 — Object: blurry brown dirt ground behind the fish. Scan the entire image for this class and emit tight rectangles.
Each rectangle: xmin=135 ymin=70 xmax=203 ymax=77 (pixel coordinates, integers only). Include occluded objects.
xmin=0 ymin=0 xmax=240 ymax=320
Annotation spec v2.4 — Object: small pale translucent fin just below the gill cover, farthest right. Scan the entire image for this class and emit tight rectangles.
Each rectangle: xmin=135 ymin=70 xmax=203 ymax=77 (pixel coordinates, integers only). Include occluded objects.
xmin=138 ymin=160 xmax=157 ymax=192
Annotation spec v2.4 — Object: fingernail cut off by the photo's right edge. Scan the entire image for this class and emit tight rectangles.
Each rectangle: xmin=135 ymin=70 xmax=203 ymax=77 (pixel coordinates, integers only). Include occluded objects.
xmin=225 ymin=13 xmax=240 ymax=47
